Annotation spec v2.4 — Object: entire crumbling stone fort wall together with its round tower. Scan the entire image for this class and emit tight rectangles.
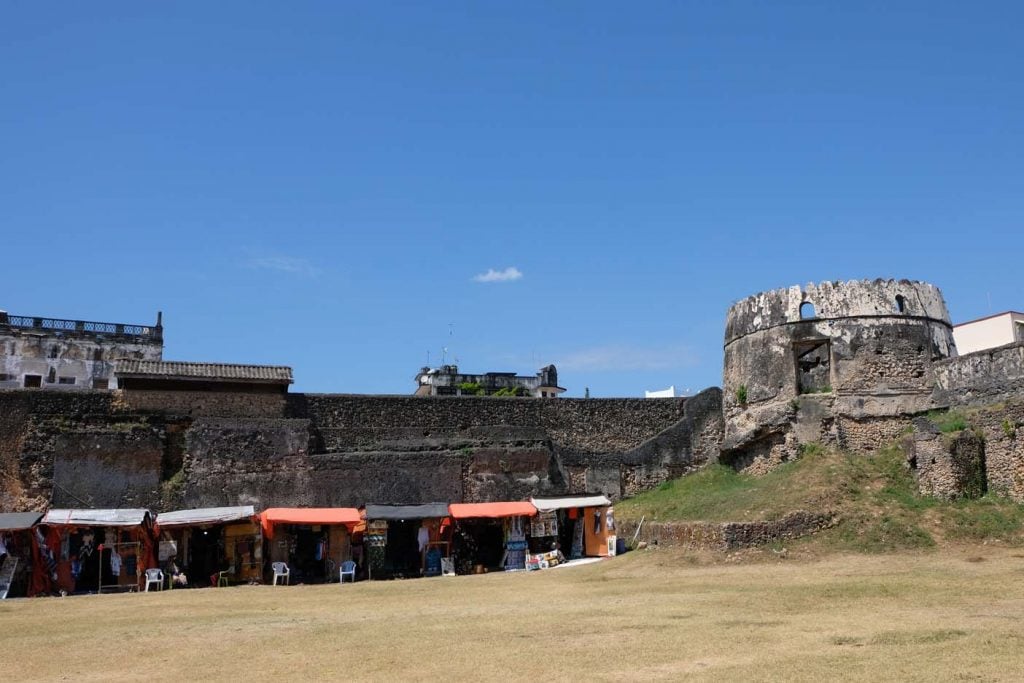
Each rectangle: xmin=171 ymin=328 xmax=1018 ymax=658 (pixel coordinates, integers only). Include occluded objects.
xmin=0 ymin=280 xmax=1024 ymax=511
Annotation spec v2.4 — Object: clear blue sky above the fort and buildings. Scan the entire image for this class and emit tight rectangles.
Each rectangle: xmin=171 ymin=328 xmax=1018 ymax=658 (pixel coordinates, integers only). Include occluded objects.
xmin=0 ymin=1 xmax=1024 ymax=396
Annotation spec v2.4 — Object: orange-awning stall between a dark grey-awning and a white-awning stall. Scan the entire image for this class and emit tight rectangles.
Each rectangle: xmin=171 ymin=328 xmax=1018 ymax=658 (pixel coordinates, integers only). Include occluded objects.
xmin=449 ymin=501 xmax=537 ymax=573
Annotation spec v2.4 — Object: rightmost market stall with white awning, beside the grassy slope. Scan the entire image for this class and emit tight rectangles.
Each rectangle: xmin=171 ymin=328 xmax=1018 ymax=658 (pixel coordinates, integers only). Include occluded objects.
xmin=529 ymin=494 xmax=615 ymax=559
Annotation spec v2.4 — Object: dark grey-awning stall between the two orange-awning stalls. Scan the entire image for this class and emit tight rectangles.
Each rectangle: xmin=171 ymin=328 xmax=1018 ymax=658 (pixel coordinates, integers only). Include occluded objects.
xmin=364 ymin=503 xmax=452 ymax=579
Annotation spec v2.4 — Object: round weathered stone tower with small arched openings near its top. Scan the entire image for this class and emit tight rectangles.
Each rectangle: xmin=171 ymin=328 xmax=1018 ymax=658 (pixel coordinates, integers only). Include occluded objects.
xmin=722 ymin=280 xmax=956 ymax=470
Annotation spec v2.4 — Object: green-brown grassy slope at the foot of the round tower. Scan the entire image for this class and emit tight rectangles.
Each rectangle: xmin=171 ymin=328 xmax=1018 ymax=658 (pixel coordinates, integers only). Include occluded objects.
xmin=615 ymin=449 xmax=1024 ymax=552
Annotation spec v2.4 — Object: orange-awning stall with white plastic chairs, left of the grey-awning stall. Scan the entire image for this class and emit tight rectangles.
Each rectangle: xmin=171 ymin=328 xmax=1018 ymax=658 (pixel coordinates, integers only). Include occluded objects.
xmin=260 ymin=508 xmax=360 ymax=584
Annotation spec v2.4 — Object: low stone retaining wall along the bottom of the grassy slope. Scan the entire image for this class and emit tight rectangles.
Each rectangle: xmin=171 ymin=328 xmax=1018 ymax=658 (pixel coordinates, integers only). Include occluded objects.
xmin=615 ymin=510 xmax=834 ymax=550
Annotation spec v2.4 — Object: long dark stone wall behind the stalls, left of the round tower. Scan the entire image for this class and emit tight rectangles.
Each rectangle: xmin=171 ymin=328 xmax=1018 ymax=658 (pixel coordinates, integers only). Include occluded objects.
xmin=0 ymin=389 xmax=722 ymax=510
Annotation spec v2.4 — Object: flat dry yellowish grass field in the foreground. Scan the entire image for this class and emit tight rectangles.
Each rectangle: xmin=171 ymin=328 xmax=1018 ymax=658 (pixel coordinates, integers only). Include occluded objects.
xmin=0 ymin=547 xmax=1024 ymax=682
